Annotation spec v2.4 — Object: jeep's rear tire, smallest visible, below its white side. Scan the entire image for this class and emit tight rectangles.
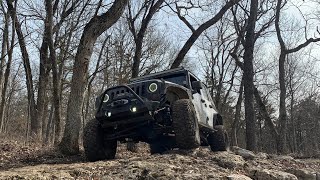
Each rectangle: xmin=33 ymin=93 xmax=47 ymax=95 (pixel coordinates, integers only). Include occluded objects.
xmin=207 ymin=125 xmax=229 ymax=152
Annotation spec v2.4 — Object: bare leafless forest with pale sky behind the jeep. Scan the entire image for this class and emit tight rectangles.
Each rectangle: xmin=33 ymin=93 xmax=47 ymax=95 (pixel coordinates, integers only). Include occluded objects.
xmin=0 ymin=0 xmax=320 ymax=156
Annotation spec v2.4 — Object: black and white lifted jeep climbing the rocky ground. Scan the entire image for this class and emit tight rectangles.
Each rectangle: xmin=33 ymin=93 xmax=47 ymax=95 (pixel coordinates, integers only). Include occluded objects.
xmin=83 ymin=68 xmax=227 ymax=161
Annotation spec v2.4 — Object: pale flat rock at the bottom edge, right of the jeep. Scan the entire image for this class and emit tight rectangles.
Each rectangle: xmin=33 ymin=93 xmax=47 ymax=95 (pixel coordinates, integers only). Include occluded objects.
xmin=249 ymin=169 xmax=298 ymax=180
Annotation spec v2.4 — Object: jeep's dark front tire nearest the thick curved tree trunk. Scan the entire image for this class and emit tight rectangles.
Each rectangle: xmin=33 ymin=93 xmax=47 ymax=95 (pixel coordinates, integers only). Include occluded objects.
xmin=83 ymin=119 xmax=117 ymax=161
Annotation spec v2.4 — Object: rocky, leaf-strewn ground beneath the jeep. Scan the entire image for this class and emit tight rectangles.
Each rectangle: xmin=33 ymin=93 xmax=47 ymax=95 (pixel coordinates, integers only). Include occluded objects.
xmin=0 ymin=141 xmax=320 ymax=180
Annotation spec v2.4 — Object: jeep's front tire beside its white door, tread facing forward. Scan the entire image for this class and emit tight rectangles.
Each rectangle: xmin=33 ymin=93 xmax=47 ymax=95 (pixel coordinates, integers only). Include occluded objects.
xmin=172 ymin=99 xmax=200 ymax=149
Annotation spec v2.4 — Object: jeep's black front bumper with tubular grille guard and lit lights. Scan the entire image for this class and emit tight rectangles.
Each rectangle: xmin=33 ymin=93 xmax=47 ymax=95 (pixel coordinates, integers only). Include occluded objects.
xmin=96 ymin=85 xmax=160 ymax=128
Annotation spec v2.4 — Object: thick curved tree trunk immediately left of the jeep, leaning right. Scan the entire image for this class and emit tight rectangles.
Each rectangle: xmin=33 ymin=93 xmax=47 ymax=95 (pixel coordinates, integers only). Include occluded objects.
xmin=59 ymin=0 xmax=128 ymax=155
